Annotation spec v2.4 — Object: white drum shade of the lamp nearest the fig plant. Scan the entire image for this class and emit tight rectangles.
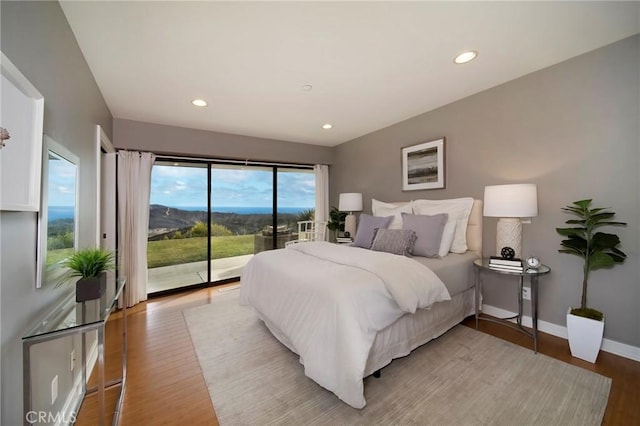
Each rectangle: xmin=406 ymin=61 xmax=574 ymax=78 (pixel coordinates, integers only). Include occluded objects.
xmin=484 ymin=183 xmax=538 ymax=217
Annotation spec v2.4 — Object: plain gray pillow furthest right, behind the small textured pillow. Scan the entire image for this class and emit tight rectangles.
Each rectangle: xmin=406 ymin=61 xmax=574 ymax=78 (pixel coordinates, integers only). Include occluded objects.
xmin=402 ymin=213 xmax=449 ymax=257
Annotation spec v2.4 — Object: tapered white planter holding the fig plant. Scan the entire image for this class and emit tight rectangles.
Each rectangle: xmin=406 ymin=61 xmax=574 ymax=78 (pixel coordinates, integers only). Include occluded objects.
xmin=567 ymin=308 xmax=604 ymax=363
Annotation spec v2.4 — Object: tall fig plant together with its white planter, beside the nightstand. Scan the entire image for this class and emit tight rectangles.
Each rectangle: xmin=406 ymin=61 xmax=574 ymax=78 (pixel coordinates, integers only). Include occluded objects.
xmin=556 ymin=200 xmax=627 ymax=362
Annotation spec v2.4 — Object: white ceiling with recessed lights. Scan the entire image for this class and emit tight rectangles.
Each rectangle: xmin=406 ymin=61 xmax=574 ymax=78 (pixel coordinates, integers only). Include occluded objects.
xmin=61 ymin=1 xmax=640 ymax=146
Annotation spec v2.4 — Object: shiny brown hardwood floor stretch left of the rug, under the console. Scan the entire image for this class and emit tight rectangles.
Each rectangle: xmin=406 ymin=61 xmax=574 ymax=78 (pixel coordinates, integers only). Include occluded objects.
xmin=76 ymin=288 xmax=219 ymax=425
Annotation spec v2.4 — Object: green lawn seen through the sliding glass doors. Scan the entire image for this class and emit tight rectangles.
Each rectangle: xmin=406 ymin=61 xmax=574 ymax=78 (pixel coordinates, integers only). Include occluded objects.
xmin=147 ymin=234 xmax=253 ymax=268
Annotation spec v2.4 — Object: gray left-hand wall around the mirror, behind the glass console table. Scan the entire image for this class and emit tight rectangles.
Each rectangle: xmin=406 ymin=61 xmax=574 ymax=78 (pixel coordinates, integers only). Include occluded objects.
xmin=0 ymin=1 xmax=112 ymax=425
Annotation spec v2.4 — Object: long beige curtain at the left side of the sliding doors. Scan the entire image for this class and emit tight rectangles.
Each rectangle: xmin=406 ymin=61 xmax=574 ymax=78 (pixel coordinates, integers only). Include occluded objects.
xmin=118 ymin=151 xmax=155 ymax=307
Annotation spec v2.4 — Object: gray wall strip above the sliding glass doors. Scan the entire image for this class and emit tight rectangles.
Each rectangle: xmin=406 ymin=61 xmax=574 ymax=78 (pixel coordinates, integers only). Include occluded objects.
xmin=113 ymin=119 xmax=334 ymax=168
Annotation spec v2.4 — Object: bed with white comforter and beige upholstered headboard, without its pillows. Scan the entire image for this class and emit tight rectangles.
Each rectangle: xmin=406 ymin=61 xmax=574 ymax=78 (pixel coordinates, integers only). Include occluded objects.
xmin=240 ymin=199 xmax=482 ymax=408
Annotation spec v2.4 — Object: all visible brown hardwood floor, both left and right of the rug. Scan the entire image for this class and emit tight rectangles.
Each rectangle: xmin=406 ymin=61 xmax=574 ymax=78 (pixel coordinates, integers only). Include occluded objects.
xmin=76 ymin=287 xmax=640 ymax=425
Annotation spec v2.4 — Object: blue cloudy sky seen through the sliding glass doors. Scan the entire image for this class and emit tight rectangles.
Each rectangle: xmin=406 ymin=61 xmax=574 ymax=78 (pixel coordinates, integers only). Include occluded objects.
xmin=151 ymin=164 xmax=315 ymax=208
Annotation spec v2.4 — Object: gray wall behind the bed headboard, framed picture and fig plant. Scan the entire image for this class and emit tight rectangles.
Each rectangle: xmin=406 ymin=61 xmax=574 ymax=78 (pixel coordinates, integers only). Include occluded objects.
xmin=330 ymin=35 xmax=640 ymax=346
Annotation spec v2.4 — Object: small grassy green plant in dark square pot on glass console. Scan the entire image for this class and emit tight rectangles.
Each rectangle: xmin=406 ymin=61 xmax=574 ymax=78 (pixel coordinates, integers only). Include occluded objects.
xmin=57 ymin=248 xmax=114 ymax=302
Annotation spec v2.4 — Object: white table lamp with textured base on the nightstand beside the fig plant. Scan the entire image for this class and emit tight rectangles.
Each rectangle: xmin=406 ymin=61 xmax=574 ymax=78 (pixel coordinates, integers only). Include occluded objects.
xmin=484 ymin=183 xmax=538 ymax=258
